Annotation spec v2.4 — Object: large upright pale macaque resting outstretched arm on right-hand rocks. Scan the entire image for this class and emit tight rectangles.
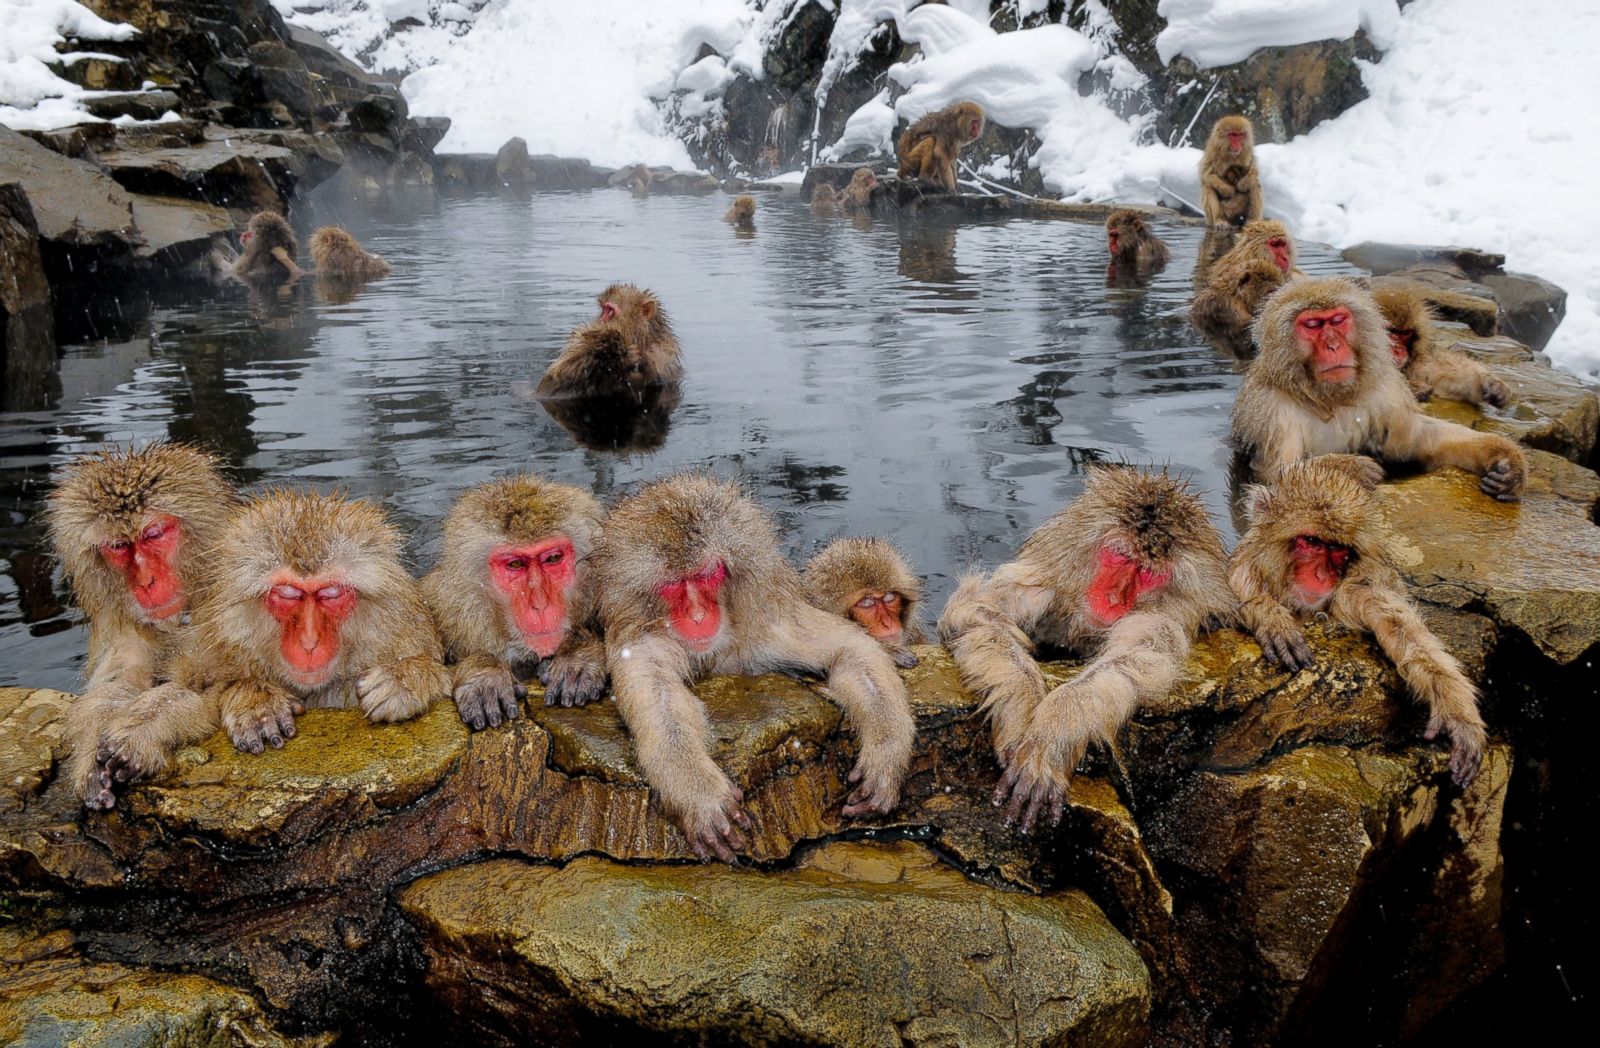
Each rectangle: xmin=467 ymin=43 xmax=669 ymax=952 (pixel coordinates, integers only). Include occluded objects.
xmin=1234 ymin=277 xmax=1528 ymax=502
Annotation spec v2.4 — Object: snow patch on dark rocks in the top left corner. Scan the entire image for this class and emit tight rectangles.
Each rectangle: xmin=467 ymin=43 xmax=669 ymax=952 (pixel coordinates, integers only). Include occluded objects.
xmin=0 ymin=0 xmax=139 ymax=130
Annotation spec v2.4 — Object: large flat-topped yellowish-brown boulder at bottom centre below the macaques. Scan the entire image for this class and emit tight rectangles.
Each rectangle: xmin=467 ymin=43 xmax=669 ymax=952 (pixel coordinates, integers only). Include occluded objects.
xmin=400 ymin=842 xmax=1150 ymax=1045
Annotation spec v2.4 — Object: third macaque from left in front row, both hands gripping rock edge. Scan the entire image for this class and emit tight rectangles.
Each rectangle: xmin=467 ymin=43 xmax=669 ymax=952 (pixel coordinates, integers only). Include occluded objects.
xmin=422 ymin=474 xmax=605 ymax=731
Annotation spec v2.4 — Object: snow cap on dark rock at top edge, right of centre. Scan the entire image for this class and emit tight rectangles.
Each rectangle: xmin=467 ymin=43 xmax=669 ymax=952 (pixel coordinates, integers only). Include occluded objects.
xmin=1155 ymin=0 xmax=1400 ymax=69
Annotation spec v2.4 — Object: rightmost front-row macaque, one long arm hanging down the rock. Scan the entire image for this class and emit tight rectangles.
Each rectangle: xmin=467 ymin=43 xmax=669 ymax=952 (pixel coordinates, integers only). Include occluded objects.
xmin=1229 ymin=456 xmax=1485 ymax=786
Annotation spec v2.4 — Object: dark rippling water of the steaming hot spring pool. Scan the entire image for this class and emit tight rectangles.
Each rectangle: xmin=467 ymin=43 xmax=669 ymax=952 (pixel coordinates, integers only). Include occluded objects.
xmin=0 ymin=190 xmax=1363 ymax=686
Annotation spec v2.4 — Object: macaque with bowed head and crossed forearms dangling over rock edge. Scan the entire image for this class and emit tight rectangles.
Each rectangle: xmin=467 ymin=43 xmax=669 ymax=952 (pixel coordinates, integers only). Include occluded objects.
xmin=939 ymin=466 xmax=1232 ymax=832
